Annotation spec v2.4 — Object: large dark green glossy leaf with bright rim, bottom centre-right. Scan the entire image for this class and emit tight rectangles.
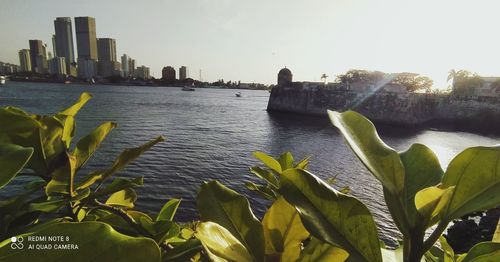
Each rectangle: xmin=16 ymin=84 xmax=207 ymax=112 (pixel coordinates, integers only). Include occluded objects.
xmin=281 ymin=169 xmax=382 ymax=262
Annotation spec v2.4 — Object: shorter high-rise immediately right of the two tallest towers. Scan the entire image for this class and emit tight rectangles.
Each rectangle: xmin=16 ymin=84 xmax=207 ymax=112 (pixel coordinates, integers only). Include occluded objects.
xmin=97 ymin=38 xmax=120 ymax=77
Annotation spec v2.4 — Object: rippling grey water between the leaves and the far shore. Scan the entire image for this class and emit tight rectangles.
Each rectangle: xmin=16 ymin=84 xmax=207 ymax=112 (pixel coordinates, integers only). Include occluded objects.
xmin=0 ymin=82 xmax=499 ymax=244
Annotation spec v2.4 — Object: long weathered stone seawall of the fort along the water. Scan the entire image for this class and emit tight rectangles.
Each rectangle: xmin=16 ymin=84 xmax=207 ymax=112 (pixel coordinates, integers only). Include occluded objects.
xmin=267 ymin=86 xmax=500 ymax=129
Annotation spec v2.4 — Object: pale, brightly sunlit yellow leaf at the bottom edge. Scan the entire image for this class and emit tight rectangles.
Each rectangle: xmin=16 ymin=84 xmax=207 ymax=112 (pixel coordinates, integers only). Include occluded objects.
xmin=195 ymin=222 xmax=252 ymax=262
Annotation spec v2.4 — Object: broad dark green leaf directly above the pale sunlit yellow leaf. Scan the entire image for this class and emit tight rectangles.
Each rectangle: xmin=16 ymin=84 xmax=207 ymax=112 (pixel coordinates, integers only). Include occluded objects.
xmin=196 ymin=181 xmax=264 ymax=261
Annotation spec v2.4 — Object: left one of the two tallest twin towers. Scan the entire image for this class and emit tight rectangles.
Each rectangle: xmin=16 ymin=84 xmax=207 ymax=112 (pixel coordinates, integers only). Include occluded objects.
xmin=53 ymin=17 xmax=75 ymax=72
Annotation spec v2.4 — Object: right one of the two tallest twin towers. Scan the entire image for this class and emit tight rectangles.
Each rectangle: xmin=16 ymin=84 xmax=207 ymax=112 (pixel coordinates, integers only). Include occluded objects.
xmin=75 ymin=16 xmax=97 ymax=78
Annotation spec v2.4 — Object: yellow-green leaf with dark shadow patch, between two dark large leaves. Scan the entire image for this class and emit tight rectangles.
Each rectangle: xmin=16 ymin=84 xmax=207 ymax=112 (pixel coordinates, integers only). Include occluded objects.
xmin=262 ymin=197 xmax=309 ymax=261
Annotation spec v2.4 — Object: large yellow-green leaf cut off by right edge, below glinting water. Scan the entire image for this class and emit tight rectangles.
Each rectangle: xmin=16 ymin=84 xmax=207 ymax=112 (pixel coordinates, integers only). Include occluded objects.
xmin=442 ymin=146 xmax=500 ymax=221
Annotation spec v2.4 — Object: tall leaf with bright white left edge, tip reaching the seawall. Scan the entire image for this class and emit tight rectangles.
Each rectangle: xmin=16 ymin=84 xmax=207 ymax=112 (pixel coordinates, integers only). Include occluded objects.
xmin=328 ymin=111 xmax=405 ymax=195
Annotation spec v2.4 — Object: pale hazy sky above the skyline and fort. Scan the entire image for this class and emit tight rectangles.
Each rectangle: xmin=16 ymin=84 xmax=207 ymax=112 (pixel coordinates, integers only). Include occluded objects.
xmin=0 ymin=0 xmax=500 ymax=87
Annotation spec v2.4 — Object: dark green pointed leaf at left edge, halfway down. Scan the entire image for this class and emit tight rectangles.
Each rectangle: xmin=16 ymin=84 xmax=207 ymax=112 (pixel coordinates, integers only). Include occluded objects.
xmin=0 ymin=144 xmax=33 ymax=188
